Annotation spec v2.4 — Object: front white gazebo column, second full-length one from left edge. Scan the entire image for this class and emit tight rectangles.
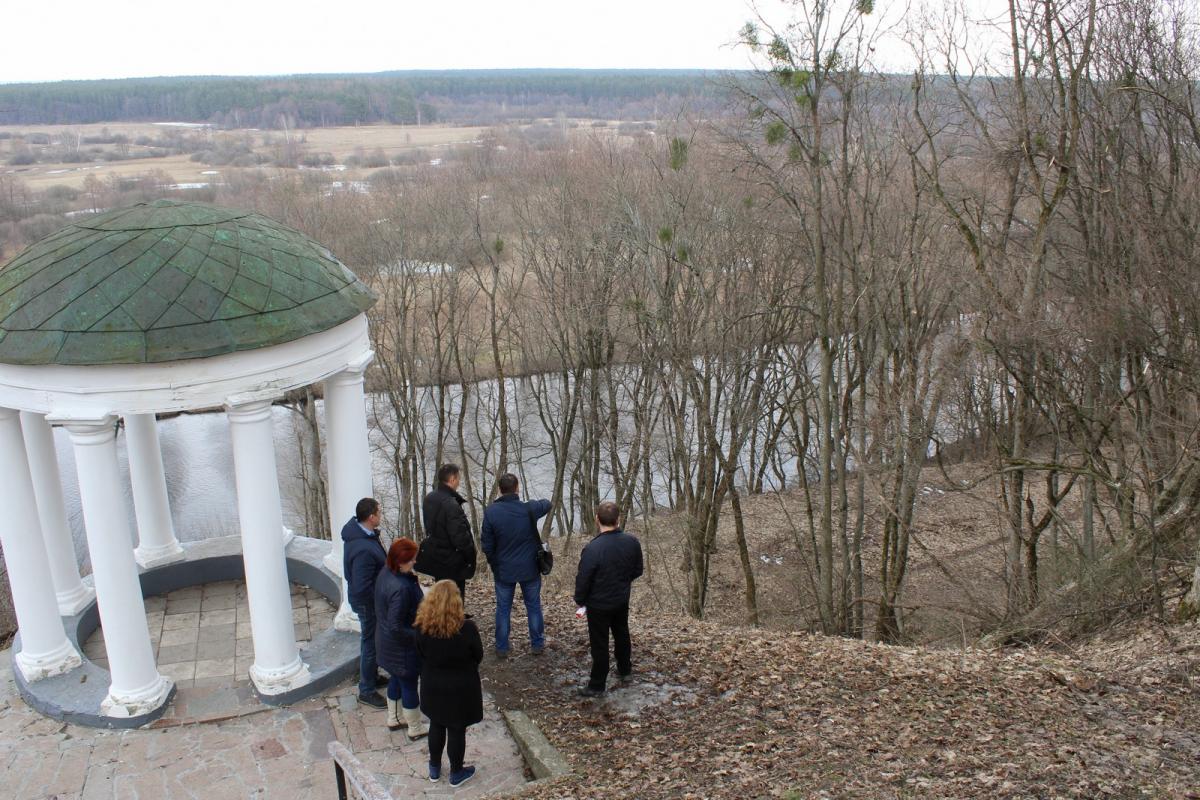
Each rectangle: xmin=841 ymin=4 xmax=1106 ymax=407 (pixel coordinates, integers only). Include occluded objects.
xmin=61 ymin=415 xmax=172 ymax=717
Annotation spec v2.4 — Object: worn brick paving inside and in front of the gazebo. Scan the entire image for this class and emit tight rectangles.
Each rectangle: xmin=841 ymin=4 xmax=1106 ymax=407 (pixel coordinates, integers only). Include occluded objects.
xmin=0 ymin=583 xmax=527 ymax=800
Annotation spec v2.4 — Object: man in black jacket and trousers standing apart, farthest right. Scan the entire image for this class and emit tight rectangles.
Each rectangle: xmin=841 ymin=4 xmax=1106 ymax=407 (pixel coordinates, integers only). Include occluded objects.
xmin=575 ymin=501 xmax=642 ymax=697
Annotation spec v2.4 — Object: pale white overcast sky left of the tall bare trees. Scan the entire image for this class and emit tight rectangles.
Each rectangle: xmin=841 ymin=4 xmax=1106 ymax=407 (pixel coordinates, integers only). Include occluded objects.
xmin=0 ymin=0 xmax=768 ymax=82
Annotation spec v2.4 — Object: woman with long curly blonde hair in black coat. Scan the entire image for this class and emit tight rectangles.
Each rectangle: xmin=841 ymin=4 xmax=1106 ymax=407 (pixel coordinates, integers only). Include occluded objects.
xmin=413 ymin=581 xmax=484 ymax=786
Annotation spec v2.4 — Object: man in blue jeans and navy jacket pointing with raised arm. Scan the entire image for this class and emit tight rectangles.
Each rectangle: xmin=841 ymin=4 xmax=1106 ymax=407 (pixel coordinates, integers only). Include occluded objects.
xmin=479 ymin=473 xmax=550 ymax=658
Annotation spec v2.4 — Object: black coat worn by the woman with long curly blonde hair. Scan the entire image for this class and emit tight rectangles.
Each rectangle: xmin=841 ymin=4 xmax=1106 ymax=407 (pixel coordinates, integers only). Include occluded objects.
xmin=416 ymin=619 xmax=484 ymax=727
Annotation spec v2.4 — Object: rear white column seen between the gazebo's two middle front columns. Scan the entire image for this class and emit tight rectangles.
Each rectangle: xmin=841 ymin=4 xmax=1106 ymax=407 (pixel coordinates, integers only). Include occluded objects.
xmin=125 ymin=414 xmax=185 ymax=569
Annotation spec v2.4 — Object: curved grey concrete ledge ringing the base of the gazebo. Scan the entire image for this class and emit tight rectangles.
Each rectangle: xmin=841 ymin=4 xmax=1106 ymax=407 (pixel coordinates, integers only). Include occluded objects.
xmin=11 ymin=536 xmax=360 ymax=728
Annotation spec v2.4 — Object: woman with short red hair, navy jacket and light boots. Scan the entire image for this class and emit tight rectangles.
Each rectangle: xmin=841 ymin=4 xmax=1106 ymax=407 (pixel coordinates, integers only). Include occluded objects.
xmin=374 ymin=539 xmax=430 ymax=741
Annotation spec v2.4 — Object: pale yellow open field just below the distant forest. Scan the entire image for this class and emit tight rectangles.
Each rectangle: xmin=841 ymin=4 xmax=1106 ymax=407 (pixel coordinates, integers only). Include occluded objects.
xmin=0 ymin=122 xmax=487 ymax=190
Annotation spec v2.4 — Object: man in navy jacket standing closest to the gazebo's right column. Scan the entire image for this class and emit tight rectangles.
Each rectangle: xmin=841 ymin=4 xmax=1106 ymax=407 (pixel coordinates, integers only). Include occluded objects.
xmin=342 ymin=498 xmax=388 ymax=709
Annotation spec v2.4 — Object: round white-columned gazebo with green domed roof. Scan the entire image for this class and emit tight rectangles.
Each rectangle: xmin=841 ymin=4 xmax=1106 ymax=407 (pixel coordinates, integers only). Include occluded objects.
xmin=0 ymin=200 xmax=376 ymax=727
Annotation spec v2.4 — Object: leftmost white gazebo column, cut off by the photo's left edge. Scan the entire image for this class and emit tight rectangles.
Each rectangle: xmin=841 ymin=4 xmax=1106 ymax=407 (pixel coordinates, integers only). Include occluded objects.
xmin=0 ymin=408 xmax=83 ymax=681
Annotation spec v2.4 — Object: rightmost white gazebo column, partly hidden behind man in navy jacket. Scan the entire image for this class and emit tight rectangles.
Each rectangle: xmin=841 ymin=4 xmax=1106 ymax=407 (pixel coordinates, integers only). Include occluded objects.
xmin=325 ymin=351 xmax=374 ymax=631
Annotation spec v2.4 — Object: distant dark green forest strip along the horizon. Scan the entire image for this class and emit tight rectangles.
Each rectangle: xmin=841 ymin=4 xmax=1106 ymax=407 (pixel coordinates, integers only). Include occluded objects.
xmin=0 ymin=70 xmax=720 ymax=128
